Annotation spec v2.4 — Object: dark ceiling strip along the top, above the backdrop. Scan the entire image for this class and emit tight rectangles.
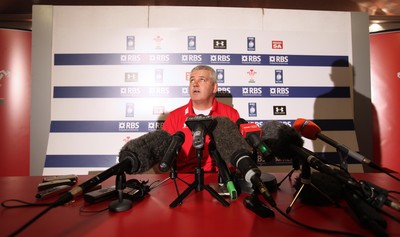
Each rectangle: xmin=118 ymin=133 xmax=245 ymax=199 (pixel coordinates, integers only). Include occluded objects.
xmin=0 ymin=0 xmax=400 ymax=29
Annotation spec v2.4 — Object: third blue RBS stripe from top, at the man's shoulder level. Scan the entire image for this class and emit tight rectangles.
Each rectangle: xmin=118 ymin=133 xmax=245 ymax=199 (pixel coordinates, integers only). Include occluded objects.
xmin=50 ymin=119 xmax=354 ymax=133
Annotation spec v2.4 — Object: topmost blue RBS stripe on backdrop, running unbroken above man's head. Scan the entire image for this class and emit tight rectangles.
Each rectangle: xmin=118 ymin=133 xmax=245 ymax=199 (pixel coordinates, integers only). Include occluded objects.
xmin=54 ymin=53 xmax=349 ymax=67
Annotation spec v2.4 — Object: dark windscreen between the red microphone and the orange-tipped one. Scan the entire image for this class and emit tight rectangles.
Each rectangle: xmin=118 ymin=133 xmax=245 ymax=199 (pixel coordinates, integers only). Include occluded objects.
xmin=261 ymin=121 xmax=304 ymax=160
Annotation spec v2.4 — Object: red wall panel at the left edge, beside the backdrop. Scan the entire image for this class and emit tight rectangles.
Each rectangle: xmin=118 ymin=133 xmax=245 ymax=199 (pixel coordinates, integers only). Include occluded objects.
xmin=0 ymin=29 xmax=32 ymax=176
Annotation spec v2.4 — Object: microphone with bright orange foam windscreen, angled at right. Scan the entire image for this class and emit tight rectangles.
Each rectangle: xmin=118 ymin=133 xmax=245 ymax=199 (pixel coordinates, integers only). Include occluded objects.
xmin=293 ymin=118 xmax=383 ymax=171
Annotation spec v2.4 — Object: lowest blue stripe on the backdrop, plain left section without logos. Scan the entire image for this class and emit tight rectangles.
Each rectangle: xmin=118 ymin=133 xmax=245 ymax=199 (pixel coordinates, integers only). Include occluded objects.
xmin=44 ymin=155 xmax=117 ymax=168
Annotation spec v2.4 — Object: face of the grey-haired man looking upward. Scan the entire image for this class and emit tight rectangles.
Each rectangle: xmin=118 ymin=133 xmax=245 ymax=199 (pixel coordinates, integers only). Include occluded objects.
xmin=189 ymin=70 xmax=218 ymax=101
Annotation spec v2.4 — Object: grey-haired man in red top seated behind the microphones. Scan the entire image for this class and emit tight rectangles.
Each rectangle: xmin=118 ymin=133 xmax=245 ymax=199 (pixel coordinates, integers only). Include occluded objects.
xmin=163 ymin=65 xmax=240 ymax=173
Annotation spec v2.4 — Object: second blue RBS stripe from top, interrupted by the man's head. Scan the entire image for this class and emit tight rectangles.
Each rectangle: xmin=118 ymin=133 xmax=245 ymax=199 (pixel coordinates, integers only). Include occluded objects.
xmin=53 ymin=86 xmax=350 ymax=99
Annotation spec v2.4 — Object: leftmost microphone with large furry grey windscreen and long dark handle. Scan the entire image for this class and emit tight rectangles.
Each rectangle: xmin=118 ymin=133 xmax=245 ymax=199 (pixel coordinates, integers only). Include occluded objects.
xmin=55 ymin=130 xmax=171 ymax=206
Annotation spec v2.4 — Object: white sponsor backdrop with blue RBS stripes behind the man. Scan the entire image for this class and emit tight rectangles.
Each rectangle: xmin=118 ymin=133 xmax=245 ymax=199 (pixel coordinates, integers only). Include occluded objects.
xmin=34 ymin=6 xmax=368 ymax=175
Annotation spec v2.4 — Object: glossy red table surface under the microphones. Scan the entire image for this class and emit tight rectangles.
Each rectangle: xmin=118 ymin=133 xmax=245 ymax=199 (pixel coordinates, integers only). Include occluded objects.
xmin=0 ymin=173 xmax=400 ymax=237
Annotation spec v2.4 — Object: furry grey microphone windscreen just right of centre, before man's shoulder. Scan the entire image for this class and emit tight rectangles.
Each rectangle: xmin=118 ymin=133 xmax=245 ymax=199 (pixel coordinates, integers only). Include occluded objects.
xmin=212 ymin=116 xmax=252 ymax=165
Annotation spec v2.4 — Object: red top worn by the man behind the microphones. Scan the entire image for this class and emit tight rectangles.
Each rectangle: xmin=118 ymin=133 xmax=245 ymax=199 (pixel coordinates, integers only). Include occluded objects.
xmin=163 ymin=98 xmax=240 ymax=173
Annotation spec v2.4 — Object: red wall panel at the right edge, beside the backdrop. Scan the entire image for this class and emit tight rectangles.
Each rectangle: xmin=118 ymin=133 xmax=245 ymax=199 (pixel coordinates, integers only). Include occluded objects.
xmin=370 ymin=31 xmax=400 ymax=172
